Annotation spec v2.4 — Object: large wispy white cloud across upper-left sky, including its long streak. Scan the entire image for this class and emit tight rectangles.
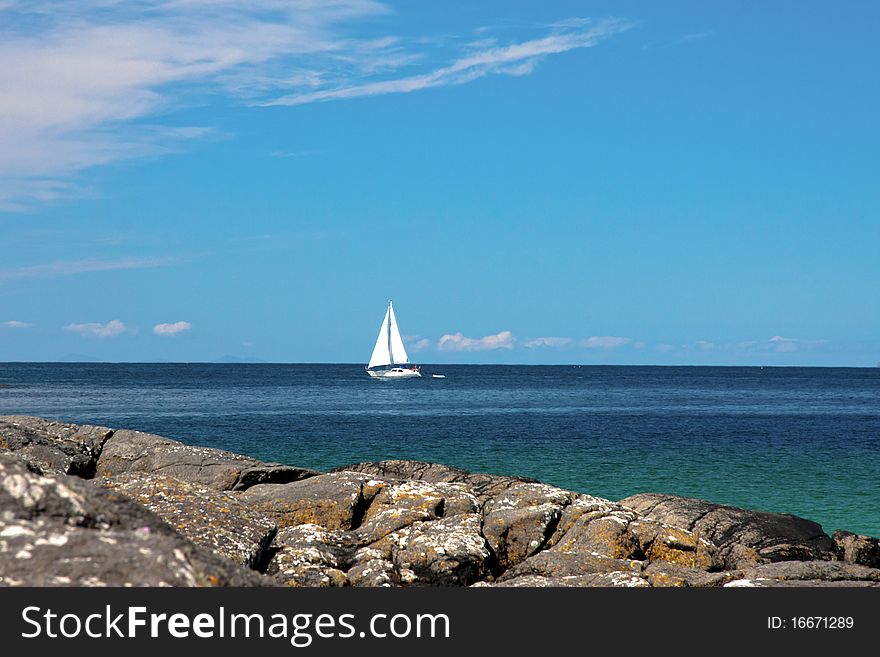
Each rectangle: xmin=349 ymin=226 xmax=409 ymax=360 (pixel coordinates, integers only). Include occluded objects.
xmin=0 ymin=0 xmax=628 ymax=211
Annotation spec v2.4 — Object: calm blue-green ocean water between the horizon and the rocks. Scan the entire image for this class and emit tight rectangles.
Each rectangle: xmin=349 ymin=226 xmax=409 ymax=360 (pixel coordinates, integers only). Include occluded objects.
xmin=0 ymin=363 xmax=880 ymax=536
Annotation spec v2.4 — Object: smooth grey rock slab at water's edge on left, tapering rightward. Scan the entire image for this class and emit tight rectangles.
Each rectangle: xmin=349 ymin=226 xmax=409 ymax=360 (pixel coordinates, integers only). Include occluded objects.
xmin=96 ymin=430 xmax=317 ymax=490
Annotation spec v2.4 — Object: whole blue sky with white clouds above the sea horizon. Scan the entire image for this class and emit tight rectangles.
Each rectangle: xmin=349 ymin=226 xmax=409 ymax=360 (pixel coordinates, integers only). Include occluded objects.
xmin=0 ymin=0 xmax=880 ymax=366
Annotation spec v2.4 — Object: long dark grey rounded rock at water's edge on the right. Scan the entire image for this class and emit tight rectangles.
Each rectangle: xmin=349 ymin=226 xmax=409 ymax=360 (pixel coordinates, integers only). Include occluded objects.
xmin=620 ymin=493 xmax=835 ymax=568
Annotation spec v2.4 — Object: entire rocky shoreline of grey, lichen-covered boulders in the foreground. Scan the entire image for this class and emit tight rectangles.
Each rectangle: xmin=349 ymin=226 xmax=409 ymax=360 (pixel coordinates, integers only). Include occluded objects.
xmin=0 ymin=416 xmax=880 ymax=587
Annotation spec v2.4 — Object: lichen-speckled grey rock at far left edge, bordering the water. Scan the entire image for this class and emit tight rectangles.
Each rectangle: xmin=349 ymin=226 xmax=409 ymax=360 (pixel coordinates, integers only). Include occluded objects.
xmin=0 ymin=415 xmax=113 ymax=479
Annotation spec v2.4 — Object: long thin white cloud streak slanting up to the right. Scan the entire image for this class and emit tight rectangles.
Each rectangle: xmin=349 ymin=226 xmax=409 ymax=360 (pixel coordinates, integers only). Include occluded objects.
xmin=264 ymin=20 xmax=629 ymax=105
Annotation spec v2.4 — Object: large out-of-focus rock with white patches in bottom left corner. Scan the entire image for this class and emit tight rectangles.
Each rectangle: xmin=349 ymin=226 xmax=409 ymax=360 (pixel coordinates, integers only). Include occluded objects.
xmin=0 ymin=455 xmax=268 ymax=586
